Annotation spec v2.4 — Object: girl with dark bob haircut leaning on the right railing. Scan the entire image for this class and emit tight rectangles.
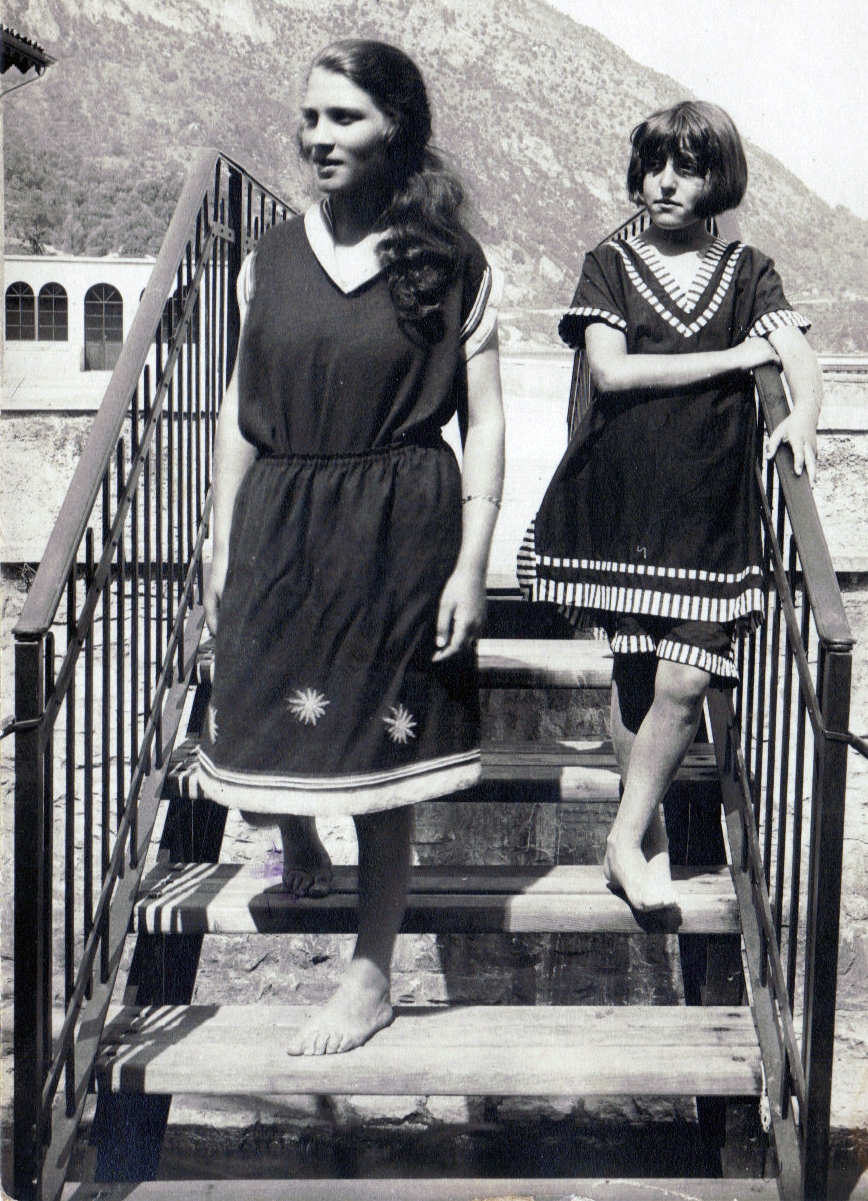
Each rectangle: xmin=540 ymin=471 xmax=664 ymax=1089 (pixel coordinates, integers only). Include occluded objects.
xmin=519 ymin=101 xmax=821 ymax=912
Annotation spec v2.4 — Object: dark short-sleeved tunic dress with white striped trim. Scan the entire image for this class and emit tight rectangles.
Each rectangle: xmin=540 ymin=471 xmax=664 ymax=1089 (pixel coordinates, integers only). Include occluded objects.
xmin=517 ymin=237 xmax=808 ymax=631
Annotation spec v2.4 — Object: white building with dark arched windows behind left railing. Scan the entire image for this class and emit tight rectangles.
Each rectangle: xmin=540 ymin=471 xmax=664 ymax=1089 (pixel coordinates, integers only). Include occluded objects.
xmin=2 ymin=255 xmax=154 ymax=410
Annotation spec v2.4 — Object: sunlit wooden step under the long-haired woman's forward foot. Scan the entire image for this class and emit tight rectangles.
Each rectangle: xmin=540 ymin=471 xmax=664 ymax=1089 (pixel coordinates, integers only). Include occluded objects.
xmin=96 ymin=1005 xmax=762 ymax=1097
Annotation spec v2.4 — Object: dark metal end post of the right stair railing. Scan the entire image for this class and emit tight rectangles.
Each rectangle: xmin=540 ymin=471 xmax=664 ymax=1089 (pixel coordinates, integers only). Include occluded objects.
xmin=802 ymin=644 xmax=852 ymax=1197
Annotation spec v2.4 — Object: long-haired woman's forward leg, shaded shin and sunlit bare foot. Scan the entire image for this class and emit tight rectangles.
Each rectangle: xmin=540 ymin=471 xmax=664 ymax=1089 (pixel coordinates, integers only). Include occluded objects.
xmin=287 ymin=806 xmax=413 ymax=1054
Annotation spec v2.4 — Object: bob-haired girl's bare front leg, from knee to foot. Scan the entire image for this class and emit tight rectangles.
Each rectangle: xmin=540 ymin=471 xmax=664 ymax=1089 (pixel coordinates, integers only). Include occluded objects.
xmin=604 ymin=659 xmax=711 ymax=910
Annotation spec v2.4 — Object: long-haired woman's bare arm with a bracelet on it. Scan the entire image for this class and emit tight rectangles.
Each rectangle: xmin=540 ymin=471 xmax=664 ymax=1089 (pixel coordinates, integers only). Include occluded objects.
xmin=433 ymin=334 xmax=504 ymax=662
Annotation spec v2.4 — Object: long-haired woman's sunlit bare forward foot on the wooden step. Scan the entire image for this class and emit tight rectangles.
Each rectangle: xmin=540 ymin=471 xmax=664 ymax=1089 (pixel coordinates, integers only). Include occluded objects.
xmin=287 ymin=961 xmax=395 ymax=1056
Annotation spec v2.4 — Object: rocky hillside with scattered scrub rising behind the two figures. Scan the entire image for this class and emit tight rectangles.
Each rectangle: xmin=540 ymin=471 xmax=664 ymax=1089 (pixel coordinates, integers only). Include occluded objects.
xmin=4 ymin=0 xmax=868 ymax=351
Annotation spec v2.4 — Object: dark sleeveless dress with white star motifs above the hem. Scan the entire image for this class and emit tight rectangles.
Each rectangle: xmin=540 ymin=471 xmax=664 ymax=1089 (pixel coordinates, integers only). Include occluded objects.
xmin=198 ymin=206 xmax=491 ymax=814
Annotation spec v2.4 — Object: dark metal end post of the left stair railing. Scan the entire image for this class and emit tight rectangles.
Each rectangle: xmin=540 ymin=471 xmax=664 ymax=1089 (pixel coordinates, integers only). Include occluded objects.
xmin=12 ymin=638 xmax=50 ymax=1201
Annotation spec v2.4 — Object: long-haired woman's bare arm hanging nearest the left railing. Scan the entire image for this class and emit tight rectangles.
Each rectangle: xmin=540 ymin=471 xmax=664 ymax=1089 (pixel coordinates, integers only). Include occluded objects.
xmin=204 ymin=329 xmax=256 ymax=634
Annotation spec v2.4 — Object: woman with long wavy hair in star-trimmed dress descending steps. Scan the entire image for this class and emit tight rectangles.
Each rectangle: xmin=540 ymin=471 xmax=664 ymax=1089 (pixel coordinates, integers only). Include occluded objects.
xmin=198 ymin=40 xmax=503 ymax=1054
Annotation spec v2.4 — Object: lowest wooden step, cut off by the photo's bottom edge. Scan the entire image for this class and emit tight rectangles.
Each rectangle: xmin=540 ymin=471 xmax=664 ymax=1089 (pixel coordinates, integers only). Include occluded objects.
xmin=62 ymin=1177 xmax=778 ymax=1201
